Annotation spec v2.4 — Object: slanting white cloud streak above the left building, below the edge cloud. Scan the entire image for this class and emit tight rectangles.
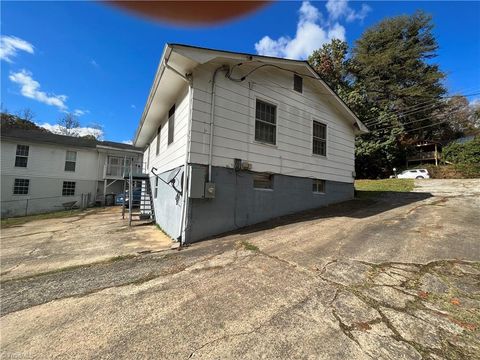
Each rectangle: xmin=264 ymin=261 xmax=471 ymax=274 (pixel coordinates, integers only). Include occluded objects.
xmin=8 ymin=70 xmax=67 ymax=110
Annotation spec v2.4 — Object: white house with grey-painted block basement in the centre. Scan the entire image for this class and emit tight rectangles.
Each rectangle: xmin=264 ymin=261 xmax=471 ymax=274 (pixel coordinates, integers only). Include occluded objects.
xmin=134 ymin=44 xmax=368 ymax=243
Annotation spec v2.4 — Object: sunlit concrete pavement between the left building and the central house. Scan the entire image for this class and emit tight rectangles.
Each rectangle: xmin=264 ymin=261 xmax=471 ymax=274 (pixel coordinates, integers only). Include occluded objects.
xmin=0 ymin=207 xmax=172 ymax=280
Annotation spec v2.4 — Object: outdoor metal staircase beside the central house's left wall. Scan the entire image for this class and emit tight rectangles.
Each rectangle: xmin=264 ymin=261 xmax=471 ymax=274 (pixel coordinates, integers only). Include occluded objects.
xmin=122 ymin=166 xmax=155 ymax=226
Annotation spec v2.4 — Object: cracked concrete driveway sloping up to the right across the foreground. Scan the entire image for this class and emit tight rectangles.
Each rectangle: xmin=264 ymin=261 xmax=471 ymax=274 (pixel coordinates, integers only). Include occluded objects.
xmin=1 ymin=181 xmax=480 ymax=359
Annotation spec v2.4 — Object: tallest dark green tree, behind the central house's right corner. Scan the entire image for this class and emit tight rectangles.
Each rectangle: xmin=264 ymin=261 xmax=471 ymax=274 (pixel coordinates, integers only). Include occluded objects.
xmin=347 ymin=12 xmax=446 ymax=177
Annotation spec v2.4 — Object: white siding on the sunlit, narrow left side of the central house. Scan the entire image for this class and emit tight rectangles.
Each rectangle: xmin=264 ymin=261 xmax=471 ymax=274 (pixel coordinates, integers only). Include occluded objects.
xmin=144 ymin=86 xmax=190 ymax=173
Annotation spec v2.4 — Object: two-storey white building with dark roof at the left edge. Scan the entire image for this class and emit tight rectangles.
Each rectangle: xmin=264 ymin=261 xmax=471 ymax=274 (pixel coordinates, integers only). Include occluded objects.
xmin=0 ymin=127 xmax=143 ymax=218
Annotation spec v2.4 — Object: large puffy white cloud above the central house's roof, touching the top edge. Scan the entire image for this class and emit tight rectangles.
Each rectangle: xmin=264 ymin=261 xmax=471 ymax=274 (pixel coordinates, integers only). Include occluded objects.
xmin=255 ymin=0 xmax=370 ymax=59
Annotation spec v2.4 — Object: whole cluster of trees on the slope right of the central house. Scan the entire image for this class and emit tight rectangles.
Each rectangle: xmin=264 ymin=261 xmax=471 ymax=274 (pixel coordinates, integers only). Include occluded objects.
xmin=308 ymin=12 xmax=480 ymax=178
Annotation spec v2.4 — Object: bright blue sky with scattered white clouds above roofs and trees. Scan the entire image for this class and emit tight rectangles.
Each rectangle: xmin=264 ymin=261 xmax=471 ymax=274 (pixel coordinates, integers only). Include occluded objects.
xmin=1 ymin=0 xmax=480 ymax=141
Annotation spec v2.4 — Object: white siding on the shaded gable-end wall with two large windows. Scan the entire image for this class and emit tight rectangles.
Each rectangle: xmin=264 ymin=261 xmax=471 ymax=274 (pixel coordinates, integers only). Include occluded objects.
xmin=189 ymin=65 xmax=355 ymax=183
